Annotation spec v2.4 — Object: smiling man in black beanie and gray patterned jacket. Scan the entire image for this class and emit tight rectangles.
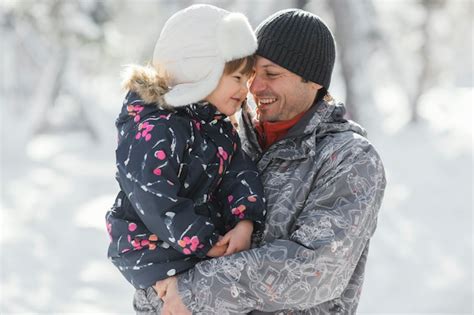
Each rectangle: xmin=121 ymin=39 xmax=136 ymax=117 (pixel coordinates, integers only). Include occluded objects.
xmin=134 ymin=9 xmax=386 ymax=314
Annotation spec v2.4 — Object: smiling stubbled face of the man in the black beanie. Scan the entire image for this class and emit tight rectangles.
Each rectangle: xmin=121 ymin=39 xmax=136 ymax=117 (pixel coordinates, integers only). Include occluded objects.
xmin=249 ymin=56 xmax=321 ymax=121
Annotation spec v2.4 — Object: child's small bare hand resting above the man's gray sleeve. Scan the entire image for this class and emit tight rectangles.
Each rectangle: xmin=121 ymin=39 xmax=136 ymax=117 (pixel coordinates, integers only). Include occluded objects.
xmin=216 ymin=220 xmax=253 ymax=255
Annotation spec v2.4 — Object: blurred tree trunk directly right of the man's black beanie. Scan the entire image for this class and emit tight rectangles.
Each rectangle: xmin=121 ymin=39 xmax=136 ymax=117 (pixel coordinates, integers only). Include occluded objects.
xmin=328 ymin=0 xmax=377 ymax=124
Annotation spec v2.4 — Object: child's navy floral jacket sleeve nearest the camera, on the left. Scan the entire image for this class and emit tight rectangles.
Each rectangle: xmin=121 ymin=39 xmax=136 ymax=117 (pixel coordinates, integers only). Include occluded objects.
xmin=116 ymin=119 xmax=218 ymax=257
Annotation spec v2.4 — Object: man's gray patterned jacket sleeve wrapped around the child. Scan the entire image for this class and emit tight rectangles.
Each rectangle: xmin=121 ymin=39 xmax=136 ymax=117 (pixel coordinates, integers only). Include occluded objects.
xmin=174 ymin=138 xmax=385 ymax=314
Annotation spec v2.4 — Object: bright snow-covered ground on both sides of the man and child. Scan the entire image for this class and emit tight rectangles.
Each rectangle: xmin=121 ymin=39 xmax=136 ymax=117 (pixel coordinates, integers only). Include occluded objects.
xmin=0 ymin=79 xmax=473 ymax=314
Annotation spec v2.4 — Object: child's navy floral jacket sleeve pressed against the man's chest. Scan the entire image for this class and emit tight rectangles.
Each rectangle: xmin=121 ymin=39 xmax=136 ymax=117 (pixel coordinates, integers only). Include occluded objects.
xmin=217 ymin=144 xmax=265 ymax=231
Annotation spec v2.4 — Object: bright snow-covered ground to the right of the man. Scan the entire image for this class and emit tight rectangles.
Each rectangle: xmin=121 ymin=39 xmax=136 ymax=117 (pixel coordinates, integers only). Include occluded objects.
xmin=359 ymin=89 xmax=473 ymax=314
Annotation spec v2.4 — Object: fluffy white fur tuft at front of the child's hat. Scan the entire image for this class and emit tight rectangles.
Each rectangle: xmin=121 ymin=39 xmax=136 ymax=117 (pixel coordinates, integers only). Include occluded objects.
xmin=217 ymin=13 xmax=257 ymax=62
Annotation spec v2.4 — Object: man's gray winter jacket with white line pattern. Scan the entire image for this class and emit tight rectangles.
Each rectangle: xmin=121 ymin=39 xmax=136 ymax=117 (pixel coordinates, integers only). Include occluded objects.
xmin=133 ymin=101 xmax=386 ymax=315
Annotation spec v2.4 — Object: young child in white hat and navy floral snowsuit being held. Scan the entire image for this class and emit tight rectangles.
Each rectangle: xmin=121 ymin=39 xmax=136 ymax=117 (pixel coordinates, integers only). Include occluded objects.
xmin=106 ymin=5 xmax=265 ymax=288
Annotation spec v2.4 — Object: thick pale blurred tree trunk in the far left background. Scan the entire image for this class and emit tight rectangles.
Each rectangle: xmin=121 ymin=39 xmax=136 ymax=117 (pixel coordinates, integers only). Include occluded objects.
xmin=15 ymin=0 xmax=111 ymax=140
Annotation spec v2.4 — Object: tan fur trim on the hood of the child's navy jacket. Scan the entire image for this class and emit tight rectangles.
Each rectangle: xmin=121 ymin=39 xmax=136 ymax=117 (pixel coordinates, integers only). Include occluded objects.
xmin=122 ymin=65 xmax=173 ymax=109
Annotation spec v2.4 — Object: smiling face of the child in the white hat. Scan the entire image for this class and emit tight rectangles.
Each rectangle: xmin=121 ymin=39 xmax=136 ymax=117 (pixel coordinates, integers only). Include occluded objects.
xmin=204 ymin=65 xmax=249 ymax=116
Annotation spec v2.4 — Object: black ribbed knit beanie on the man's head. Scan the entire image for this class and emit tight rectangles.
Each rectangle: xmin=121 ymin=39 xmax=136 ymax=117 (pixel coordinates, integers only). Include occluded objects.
xmin=256 ymin=9 xmax=336 ymax=89
